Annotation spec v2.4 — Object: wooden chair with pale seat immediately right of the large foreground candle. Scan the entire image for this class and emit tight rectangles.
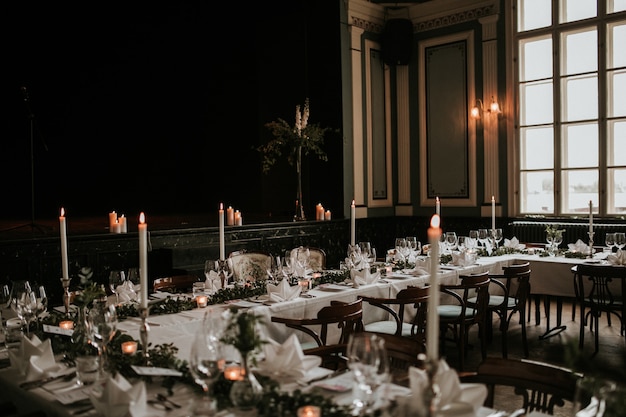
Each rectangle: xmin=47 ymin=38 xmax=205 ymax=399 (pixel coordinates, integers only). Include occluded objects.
xmin=437 ymin=272 xmax=491 ymax=370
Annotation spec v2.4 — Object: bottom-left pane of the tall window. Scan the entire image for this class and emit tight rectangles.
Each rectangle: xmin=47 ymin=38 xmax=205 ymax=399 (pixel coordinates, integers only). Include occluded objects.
xmin=520 ymin=171 xmax=554 ymax=214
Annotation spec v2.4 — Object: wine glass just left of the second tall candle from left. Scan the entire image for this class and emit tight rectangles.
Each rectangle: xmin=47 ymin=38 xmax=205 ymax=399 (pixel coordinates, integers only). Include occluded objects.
xmin=87 ymin=300 xmax=117 ymax=376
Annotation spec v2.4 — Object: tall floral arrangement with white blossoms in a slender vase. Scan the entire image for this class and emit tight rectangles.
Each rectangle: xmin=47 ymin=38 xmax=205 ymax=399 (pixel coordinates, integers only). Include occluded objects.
xmin=257 ymin=98 xmax=335 ymax=220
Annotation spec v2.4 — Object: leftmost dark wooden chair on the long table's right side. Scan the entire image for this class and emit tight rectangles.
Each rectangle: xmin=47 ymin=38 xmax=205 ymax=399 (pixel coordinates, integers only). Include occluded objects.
xmin=271 ymin=299 xmax=363 ymax=350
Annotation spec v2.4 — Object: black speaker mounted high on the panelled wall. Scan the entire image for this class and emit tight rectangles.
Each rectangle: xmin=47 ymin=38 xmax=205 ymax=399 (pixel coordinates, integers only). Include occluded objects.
xmin=381 ymin=19 xmax=413 ymax=65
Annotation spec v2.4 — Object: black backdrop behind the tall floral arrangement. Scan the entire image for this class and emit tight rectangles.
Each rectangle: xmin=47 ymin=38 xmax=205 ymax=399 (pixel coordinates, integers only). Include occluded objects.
xmin=0 ymin=0 xmax=344 ymax=228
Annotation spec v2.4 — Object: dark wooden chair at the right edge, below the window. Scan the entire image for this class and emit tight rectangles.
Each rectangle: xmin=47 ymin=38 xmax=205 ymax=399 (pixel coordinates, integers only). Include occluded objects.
xmin=572 ymin=264 xmax=626 ymax=356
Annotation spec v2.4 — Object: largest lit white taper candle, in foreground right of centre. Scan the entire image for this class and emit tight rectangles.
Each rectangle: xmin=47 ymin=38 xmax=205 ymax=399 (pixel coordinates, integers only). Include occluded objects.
xmin=426 ymin=214 xmax=441 ymax=361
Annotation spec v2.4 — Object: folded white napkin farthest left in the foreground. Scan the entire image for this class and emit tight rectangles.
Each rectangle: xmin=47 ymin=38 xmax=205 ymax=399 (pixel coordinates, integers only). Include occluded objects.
xmin=9 ymin=335 xmax=61 ymax=381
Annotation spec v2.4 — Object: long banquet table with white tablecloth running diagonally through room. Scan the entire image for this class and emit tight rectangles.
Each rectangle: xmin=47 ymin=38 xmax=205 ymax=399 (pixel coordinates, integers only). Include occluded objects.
xmin=0 ymin=250 xmax=604 ymax=417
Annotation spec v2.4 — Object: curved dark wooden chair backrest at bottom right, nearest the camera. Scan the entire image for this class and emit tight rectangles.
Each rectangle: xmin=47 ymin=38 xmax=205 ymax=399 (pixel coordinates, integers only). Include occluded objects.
xmin=461 ymin=358 xmax=582 ymax=414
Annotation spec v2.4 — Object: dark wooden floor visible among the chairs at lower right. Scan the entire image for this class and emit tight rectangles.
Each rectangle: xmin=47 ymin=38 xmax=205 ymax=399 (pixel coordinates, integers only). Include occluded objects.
xmin=454 ymin=294 xmax=626 ymax=417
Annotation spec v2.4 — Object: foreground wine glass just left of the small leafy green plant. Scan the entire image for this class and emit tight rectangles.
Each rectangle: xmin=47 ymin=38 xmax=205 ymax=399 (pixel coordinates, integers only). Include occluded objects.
xmin=189 ymin=312 xmax=225 ymax=414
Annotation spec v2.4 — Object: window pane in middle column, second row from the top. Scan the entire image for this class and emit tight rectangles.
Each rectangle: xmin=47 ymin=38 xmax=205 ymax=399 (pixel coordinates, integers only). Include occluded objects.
xmin=561 ymin=30 xmax=598 ymax=75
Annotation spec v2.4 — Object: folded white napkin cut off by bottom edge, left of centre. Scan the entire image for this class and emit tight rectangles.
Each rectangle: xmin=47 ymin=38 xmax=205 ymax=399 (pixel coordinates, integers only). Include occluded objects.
xmin=89 ymin=373 xmax=147 ymax=417
